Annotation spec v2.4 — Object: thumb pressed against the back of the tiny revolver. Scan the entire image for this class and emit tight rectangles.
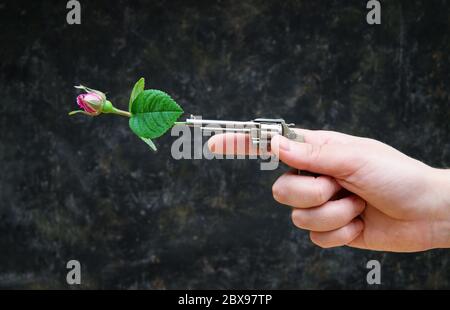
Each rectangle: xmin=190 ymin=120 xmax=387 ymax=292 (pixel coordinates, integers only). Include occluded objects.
xmin=271 ymin=135 xmax=365 ymax=177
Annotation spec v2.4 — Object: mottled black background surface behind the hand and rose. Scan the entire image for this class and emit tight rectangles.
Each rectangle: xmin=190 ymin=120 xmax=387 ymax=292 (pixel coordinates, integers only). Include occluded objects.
xmin=0 ymin=0 xmax=450 ymax=289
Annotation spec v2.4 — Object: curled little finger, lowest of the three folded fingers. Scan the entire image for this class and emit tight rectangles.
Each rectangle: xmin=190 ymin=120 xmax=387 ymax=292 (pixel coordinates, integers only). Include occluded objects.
xmin=310 ymin=218 xmax=364 ymax=248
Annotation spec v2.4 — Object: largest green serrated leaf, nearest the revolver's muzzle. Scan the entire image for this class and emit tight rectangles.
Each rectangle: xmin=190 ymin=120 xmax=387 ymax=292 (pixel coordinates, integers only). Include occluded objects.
xmin=130 ymin=89 xmax=183 ymax=139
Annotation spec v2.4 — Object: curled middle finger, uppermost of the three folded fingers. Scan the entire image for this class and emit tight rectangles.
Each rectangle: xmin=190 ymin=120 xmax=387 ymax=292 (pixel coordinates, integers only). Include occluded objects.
xmin=272 ymin=172 xmax=341 ymax=208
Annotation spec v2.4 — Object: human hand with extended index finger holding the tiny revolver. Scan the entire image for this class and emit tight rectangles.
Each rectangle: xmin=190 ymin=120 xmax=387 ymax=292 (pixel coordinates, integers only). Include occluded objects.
xmin=208 ymin=129 xmax=450 ymax=252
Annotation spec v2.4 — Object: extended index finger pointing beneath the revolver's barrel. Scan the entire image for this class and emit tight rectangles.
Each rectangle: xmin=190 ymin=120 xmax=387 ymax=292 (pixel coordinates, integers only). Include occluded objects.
xmin=208 ymin=133 xmax=258 ymax=155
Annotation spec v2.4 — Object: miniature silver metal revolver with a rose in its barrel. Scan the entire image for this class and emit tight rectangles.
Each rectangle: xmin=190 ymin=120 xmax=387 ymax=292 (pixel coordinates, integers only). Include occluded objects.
xmin=184 ymin=115 xmax=303 ymax=145
